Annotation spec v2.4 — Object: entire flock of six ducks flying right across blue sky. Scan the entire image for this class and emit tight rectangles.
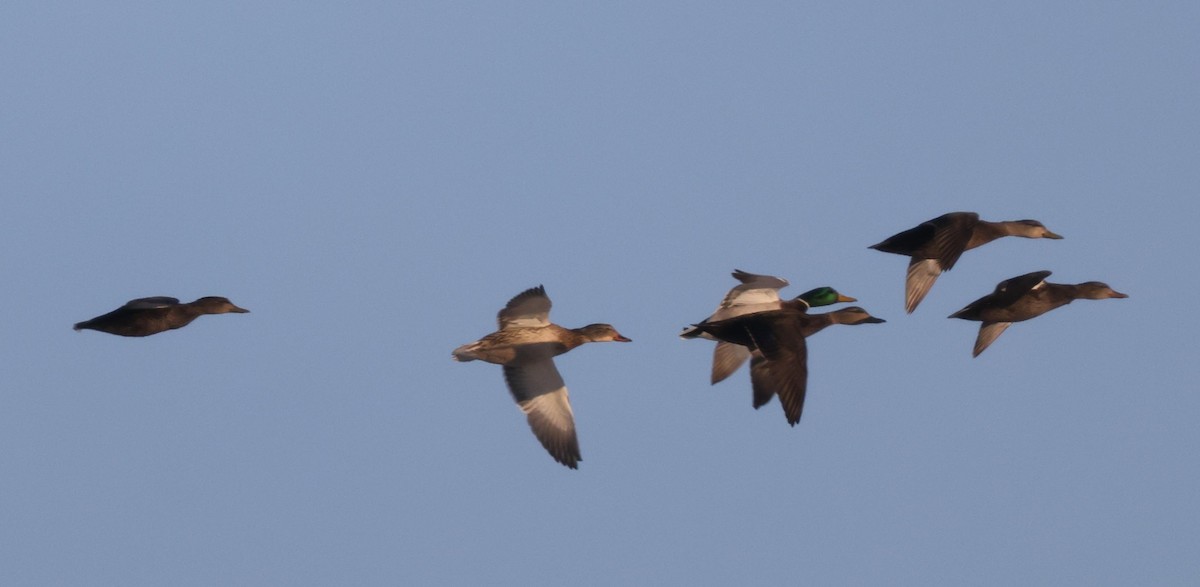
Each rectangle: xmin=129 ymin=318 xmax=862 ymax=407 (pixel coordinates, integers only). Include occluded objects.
xmin=74 ymin=212 xmax=1128 ymax=468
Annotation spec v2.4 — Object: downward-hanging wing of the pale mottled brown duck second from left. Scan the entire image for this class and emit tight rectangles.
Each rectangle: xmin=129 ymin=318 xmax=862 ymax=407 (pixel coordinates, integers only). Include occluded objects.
xmin=504 ymin=358 xmax=583 ymax=469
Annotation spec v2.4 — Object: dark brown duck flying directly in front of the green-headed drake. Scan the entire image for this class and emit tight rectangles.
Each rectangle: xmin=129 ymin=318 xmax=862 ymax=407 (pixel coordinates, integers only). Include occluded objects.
xmin=695 ymin=300 xmax=883 ymax=426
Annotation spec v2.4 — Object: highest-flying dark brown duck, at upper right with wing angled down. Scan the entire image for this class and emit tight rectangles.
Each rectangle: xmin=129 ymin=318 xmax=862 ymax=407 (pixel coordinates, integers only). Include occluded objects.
xmin=868 ymin=208 xmax=1062 ymax=313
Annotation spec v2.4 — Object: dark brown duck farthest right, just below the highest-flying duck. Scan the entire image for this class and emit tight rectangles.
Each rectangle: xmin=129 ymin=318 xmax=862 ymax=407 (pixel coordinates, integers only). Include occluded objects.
xmin=949 ymin=271 xmax=1128 ymax=357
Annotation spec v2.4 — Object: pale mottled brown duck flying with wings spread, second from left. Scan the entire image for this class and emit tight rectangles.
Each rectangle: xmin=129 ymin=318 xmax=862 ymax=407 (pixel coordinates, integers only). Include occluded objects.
xmin=451 ymin=286 xmax=631 ymax=469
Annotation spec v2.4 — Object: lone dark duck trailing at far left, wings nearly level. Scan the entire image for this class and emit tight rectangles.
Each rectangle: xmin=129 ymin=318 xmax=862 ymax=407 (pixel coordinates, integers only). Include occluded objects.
xmin=74 ymin=295 xmax=250 ymax=336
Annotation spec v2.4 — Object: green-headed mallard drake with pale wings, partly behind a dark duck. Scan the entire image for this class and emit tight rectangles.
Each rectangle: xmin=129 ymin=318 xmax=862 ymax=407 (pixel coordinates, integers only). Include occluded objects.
xmin=679 ymin=269 xmax=858 ymax=385
